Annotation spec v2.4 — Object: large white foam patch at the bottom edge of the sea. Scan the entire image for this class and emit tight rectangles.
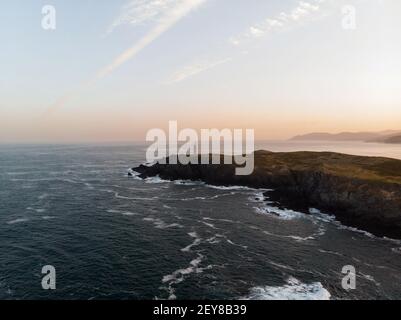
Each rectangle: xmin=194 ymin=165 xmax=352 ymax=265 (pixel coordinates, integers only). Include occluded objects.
xmin=243 ymin=277 xmax=331 ymax=300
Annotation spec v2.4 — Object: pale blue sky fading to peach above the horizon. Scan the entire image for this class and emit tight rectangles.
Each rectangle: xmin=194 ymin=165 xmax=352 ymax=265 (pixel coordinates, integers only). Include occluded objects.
xmin=0 ymin=0 xmax=401 ymax=143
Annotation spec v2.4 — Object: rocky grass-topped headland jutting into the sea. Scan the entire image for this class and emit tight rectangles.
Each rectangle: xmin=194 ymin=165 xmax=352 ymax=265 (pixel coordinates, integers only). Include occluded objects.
xmin=134 ymin=151 xmax=401 ymax=238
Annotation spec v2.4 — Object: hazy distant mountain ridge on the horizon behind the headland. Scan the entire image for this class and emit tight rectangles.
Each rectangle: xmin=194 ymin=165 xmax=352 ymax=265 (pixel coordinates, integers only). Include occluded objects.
xmin=290 ymin=130 xmax=401 ymax=143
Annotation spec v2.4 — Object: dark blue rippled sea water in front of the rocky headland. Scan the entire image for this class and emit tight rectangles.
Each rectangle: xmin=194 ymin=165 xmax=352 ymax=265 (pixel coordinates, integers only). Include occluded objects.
xmin=0 ymin=145 xmax=401 ymax=299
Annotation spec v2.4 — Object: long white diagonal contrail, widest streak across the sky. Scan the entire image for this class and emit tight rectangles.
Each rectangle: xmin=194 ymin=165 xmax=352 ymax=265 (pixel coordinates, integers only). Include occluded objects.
xmin=47 ymin=0 xmax=207 ymax=113
